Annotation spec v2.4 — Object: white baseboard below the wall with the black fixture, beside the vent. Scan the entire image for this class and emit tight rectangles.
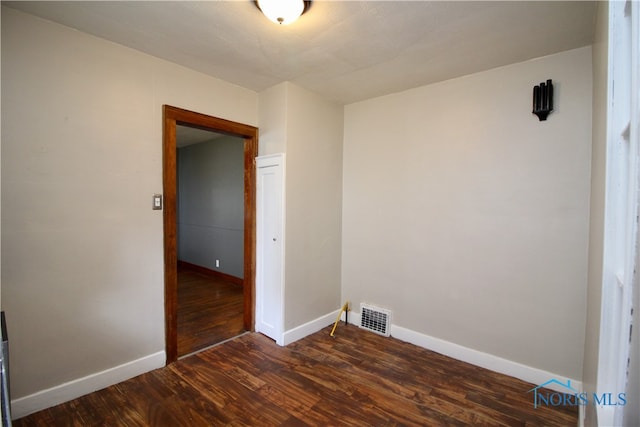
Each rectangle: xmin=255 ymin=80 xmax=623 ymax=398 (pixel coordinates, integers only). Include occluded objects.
xmin=342 ymin=312 xmax=582 ymax=392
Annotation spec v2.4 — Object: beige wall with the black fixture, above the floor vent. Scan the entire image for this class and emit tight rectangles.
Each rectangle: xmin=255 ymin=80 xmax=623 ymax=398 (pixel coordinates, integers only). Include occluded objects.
xmin=342 ymin=47 xmax=591 ymax=380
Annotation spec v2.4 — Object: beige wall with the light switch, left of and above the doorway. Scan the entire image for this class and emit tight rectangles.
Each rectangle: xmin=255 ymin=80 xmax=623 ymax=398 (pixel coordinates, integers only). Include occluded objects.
xmin=2 ymin=7 xmax=258 ymax=399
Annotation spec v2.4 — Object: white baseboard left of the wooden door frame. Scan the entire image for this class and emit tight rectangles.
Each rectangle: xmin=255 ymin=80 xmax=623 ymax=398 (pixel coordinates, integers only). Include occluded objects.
xmin=11 ymin=351 xmax=166 ymax=419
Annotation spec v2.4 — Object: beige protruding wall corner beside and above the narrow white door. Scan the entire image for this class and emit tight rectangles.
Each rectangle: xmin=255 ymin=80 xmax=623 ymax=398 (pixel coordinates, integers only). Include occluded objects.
xmin=260 ymin=82 xmax=343 ymax=331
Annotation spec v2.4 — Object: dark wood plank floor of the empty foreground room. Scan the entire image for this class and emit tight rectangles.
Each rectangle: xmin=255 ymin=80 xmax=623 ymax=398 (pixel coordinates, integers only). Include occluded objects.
xmin=14 ymin=323 xmax=578 ymax=427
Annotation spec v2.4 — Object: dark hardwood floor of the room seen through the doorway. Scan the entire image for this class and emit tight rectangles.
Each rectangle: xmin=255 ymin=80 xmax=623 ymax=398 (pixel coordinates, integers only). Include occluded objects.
xmin=178 ymin=265 xmax=244 ymax=357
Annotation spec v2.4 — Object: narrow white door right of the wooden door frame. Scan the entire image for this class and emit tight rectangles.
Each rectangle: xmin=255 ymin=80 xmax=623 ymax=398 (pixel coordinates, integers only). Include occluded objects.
xmin=256 ymin=154 xmax=284 ymax=345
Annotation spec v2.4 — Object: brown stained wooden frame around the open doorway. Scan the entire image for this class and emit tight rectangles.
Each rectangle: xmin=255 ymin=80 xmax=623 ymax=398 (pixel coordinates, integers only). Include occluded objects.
xmin=162 ymin=105 xmax=258 ymax=365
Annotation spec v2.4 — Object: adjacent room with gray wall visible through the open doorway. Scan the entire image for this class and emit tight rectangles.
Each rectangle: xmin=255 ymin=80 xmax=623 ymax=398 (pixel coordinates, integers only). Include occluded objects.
xmin=176 ymin=125 xmax=245 ymax=357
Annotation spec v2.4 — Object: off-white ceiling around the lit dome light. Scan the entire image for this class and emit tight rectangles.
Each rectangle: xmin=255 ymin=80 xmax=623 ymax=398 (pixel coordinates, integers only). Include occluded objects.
xmin=2 ymin=0 xmax=596 ymax=104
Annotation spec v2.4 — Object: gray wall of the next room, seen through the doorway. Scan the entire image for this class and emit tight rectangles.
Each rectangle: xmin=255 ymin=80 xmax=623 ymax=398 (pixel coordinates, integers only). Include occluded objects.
xmin=178 ymin=137 xmax=244 ymax=278
